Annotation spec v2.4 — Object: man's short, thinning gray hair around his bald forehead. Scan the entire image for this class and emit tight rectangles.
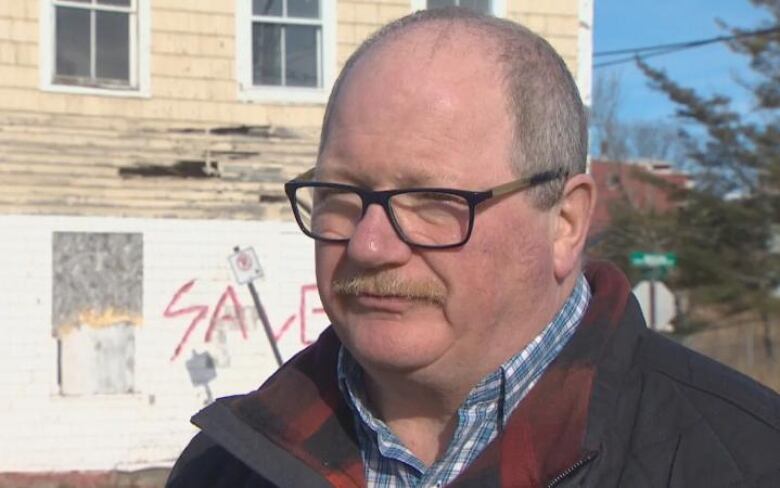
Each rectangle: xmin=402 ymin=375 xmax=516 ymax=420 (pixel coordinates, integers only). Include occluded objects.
xmin=319 ymin=8 xmax=588 ymax=208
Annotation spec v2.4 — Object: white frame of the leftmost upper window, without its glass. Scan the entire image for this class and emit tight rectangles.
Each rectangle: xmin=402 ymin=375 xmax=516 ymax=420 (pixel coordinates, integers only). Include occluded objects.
xmin=38 ymin=0 xmax=151 ymax=98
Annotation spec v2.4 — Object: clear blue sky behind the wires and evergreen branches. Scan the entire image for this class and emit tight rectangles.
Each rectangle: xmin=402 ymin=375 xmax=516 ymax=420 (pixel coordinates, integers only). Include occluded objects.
xmin=593 ymin=0 xmax=769 ymax=121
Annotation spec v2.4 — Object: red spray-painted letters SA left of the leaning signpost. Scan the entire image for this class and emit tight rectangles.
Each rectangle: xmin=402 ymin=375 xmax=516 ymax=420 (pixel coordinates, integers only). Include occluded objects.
xmin=163 ymin=280 xmax=247 ymax=361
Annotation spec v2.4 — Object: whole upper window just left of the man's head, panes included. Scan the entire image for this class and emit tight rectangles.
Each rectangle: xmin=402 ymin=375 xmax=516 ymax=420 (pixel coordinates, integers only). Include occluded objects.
xmin=237 ymin=0 xmax=334 ymax=101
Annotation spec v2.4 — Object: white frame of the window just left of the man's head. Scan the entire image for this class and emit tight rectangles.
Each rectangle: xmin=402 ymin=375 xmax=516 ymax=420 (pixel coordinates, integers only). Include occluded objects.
xmin=236 ymin=0 xmax=336 ymax=103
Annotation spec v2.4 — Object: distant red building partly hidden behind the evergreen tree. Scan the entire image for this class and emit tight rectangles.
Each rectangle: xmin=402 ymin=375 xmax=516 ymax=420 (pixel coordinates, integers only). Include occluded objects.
xmin=590 ymin=159 xmax=692 ymax=235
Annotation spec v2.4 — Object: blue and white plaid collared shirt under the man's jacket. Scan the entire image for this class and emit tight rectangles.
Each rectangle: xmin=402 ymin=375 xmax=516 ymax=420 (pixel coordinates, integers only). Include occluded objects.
xmin=338 ymin=275 xmax=591 ymax=488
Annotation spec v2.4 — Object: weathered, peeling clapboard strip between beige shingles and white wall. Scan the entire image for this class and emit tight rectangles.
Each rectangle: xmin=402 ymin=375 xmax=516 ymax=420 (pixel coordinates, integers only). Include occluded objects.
xmin=0 ymin=110 xmax=318 ymax=219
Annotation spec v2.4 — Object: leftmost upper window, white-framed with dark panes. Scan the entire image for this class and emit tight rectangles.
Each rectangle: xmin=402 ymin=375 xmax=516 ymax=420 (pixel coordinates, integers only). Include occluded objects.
xmin=41 ymin=0 xmax=148 ymax=96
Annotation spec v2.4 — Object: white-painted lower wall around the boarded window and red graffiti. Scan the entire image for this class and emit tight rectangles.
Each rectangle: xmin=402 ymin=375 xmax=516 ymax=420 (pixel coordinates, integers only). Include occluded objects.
xmin=0 ymin=216 xmax=327 ymax=472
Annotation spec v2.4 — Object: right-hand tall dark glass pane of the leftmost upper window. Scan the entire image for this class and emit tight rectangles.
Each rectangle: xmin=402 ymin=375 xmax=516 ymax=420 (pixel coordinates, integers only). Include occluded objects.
xmin=95 ymin=11 xmax=130 ymax=81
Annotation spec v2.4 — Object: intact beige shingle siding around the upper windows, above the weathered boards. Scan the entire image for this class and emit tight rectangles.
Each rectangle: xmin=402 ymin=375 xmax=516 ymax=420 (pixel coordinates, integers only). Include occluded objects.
xmin=0 ymin=0 xmax=578 ymax=127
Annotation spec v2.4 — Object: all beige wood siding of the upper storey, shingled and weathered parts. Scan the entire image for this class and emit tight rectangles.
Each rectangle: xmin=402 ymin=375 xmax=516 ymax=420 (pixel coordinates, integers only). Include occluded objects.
xmin=0 ymin=0 xmax=578 ymax=219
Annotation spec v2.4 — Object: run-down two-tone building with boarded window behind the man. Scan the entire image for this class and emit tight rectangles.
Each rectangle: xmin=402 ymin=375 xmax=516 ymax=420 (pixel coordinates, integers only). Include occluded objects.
xmin=0 ymin=0 xmax=593 ymax=481
